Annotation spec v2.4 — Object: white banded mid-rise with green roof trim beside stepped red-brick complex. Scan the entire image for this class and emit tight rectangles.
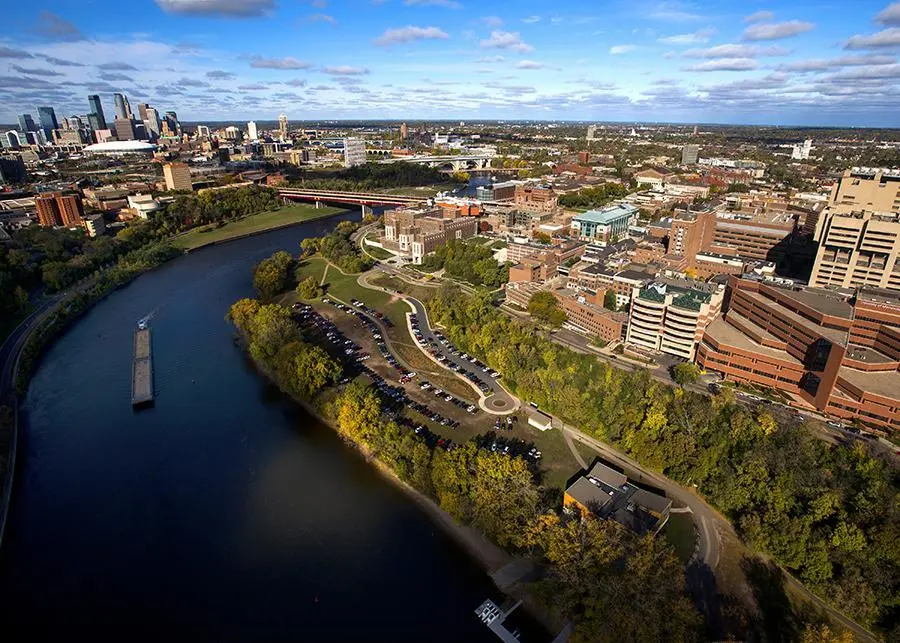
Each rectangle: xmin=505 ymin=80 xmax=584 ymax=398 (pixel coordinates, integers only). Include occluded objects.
xmin=626 ymin=279 xmax=725 ymax=360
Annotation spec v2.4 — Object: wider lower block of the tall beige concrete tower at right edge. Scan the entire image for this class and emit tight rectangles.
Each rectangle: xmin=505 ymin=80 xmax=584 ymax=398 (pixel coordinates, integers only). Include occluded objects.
xmin=809 ymin=210 xmax=900 ymax=290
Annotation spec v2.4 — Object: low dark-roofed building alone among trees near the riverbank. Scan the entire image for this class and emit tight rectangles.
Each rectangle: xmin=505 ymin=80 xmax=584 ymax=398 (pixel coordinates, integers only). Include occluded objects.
xmin=563 ymin=461 xmax=672 ymax=535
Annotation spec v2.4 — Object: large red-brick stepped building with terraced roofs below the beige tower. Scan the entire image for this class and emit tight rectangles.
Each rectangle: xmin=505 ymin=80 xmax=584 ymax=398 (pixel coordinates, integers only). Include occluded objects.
xmin=697 ymin=277 xmax=900 ymax=431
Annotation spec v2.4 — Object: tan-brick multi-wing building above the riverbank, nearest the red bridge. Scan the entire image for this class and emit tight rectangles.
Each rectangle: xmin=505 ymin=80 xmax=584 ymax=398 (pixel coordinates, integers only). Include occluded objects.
xmin=382 ymin=208 xmax=478 ymax=264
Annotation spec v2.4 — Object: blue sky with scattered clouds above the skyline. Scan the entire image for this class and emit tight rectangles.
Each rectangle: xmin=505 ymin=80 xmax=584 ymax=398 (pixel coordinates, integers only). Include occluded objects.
xmin=0 ymin=0 xmax=900 ymax=127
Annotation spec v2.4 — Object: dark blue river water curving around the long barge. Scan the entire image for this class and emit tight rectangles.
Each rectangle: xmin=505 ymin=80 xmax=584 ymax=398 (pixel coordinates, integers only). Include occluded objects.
xmin=0 ymin=212 xmax=506 ymax=641
